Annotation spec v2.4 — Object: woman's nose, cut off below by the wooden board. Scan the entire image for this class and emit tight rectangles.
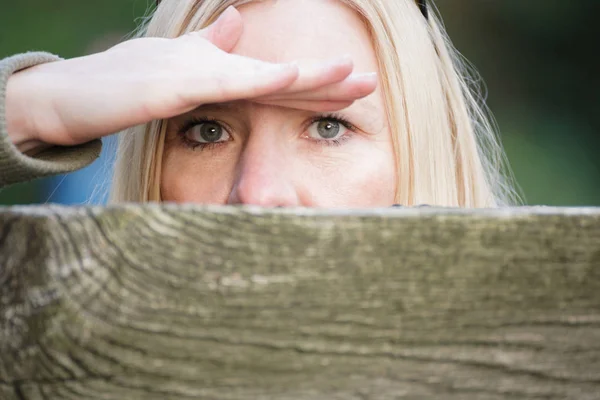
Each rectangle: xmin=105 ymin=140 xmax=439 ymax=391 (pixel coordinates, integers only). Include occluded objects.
xmin=227 ymin=146 xmax=300 ymax=207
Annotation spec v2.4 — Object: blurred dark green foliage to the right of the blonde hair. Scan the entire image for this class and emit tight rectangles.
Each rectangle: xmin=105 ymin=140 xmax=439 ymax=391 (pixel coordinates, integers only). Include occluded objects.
xmin=437 ymin=0 xmax=600 ymax=205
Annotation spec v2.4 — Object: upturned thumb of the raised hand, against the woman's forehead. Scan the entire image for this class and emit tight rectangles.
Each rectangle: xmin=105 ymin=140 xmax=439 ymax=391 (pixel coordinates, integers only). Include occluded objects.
xmin=197 ymin=6 xmax=244 ymax=53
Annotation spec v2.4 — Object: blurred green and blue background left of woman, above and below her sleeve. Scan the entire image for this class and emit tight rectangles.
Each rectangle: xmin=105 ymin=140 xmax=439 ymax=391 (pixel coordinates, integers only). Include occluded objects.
xmin=0 ymin=0 xmax=149 ymax=204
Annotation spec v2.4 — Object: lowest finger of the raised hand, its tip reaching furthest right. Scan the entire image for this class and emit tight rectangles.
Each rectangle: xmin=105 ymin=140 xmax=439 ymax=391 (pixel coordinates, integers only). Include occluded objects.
xmin=255 ymin=73 xmax=377 ymax=102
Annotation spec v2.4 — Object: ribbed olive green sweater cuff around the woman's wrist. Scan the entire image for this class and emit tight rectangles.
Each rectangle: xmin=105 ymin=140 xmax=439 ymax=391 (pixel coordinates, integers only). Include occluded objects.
xmin=0 ymin=52 xmax=102 ymax=188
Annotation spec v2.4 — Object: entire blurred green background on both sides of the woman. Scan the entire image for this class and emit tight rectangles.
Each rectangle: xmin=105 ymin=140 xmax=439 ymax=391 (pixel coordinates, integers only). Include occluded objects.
xmin=0 ymin=0 xmax=600 ymax=206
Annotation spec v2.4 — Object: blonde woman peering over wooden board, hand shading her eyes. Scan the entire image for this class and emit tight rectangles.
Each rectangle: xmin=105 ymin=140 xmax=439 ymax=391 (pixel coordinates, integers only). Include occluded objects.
xmin=0 ymin=0 xmax=512 ymax=207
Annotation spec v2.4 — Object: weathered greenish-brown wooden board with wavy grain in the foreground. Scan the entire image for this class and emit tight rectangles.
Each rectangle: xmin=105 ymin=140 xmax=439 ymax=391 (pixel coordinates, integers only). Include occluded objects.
xmin=0 ymin=205 xmax=600 ymax=400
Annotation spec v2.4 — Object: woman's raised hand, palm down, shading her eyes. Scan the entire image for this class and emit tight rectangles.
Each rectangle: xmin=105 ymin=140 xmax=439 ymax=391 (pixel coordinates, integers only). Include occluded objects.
xmin=6 ymin=7 xmax=376 ymax=149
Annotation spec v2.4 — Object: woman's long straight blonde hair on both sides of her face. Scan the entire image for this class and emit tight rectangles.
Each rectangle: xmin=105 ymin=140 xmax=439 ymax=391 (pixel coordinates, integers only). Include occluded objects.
xmin=111 ymin=0 xmax=517 ymax=207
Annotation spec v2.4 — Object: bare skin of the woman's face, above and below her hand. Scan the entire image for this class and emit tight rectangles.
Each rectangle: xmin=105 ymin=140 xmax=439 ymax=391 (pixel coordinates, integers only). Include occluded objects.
xmin=161 ymin=0 xmax=397 ymax=208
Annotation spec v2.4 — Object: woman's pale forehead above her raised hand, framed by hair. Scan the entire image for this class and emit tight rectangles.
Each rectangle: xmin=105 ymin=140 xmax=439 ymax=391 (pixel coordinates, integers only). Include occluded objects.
xmin=233 ymin=0 xmax=377 ymax=72
